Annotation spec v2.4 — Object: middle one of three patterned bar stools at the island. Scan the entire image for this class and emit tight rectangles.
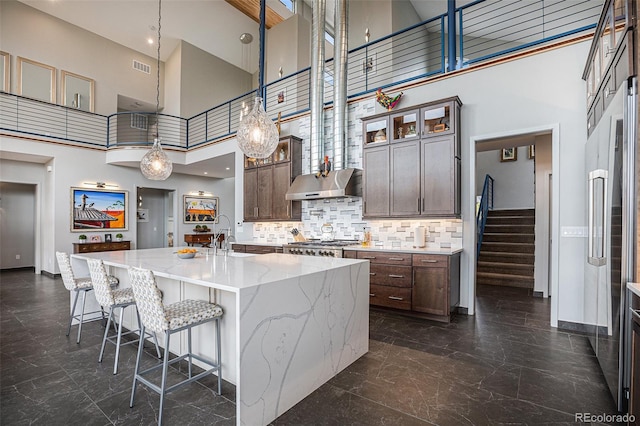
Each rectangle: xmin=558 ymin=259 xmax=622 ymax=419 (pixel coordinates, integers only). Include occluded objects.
xmin=87 ymin=259 xmax=161 ymax=374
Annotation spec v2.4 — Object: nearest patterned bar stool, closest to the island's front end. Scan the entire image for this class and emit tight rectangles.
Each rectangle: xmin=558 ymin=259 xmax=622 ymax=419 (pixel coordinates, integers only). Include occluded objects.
xmin=129 ymin=267 xmax=222 ymax=426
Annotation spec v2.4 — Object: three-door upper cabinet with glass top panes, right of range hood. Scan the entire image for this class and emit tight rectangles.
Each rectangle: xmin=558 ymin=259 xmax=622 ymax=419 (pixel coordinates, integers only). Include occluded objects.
xmin=363 ymin=97 xmax=462 ymax=218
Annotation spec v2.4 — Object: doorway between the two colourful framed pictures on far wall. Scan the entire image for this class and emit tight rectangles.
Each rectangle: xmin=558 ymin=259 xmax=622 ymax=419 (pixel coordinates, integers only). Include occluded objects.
xmin=136 ymin=187 xmax=175 ymax=249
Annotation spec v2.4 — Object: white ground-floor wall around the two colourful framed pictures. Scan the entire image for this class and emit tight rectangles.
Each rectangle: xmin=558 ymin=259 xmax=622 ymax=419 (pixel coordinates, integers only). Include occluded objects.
xmin=0 ymin=136 xmax=235 ymax=273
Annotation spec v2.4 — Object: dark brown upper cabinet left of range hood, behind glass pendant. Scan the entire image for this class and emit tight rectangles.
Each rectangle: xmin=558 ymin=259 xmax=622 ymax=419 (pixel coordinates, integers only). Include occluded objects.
xmin=244 ymin=136 xmax=302 ymax=222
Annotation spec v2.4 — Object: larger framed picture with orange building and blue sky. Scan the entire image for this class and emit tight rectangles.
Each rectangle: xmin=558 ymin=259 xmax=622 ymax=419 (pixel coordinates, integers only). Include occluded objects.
xmin=70 ymin=187 xmax=129 ymax=232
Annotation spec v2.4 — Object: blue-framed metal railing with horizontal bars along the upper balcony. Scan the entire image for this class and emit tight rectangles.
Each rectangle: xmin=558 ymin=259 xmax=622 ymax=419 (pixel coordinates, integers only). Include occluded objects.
xmin=0 ymin=0 xmax=604 ymax=149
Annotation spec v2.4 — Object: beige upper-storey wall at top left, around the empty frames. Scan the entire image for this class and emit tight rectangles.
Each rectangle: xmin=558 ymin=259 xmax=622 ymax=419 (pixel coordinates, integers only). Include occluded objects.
xmin=0 ymin=1 xmax=164 ymax=115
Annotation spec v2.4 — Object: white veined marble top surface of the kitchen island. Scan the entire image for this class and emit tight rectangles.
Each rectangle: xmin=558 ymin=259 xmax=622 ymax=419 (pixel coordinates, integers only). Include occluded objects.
xmin=72 ymin=247 xmax=367 ymax=292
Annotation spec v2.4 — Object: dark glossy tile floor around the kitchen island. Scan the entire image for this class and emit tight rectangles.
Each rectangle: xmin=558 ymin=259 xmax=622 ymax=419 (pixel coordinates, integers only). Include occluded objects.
xmin=0 ymin=271 xmax=615 ymax=426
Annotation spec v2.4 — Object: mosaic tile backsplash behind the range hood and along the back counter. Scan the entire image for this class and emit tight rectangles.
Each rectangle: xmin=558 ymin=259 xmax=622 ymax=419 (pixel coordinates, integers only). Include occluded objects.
xmin=248 ymin=99 xmax=462 ymax=249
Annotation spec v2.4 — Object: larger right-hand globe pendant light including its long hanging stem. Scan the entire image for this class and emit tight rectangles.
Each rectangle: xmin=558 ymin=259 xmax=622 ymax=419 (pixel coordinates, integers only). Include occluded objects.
xmin=236 ymin=0 xmax=279 ymax=158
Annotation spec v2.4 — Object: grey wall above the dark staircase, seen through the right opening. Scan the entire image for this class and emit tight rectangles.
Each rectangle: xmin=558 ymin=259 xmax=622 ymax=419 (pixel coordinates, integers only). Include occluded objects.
xmin=476 ymin=146 xmax=535 ymax=210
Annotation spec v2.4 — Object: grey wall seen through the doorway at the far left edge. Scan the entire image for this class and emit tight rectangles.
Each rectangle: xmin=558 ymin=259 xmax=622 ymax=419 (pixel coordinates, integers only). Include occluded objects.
xmin=0 ymin=181 xmax=36 ymax=269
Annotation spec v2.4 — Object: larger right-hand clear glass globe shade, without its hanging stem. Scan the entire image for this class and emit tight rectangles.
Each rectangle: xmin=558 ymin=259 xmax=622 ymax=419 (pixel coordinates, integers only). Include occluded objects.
xmin=236 ymin=97 xmax=279 ymax=158
